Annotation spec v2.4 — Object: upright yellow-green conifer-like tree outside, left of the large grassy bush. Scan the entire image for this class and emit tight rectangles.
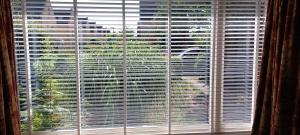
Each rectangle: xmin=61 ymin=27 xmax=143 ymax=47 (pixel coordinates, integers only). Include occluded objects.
xmin=32 ymin=35 xmax=75 ymax=131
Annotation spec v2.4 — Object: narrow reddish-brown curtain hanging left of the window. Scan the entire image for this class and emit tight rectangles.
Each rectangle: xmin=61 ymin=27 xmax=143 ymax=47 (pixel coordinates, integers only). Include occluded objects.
xmin=0 ymin=0 xmax=20 ymax=135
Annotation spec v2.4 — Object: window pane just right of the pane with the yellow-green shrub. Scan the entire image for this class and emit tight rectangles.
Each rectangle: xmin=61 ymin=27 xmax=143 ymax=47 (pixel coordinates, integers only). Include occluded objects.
xmin=78 ymin=0 xmax=124 ymax=134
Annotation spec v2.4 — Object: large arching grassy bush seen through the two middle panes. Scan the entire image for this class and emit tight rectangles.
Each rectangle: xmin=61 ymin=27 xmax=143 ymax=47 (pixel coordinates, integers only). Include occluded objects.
xmin=81 ymin=34 xmax=166 ymax=126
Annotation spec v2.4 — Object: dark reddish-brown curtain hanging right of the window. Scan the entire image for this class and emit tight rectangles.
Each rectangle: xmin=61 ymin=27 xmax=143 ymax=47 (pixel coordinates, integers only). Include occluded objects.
xmin=252 ymin=0 xmax=300 ymax=135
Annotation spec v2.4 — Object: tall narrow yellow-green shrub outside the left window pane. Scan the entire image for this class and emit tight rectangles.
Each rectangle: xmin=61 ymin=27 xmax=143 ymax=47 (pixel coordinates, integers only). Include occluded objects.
xmin=32 ymin=37 xmax=63 ymax=131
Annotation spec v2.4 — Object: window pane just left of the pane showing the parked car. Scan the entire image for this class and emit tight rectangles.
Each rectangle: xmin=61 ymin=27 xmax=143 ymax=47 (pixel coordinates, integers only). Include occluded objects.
xmin=125 ymin=0 xmax=168 ymax=134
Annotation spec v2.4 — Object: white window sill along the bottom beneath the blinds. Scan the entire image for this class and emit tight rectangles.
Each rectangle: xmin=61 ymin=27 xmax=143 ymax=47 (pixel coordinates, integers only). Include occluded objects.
xmin=22 ymin=123 xmax=251 ymax=135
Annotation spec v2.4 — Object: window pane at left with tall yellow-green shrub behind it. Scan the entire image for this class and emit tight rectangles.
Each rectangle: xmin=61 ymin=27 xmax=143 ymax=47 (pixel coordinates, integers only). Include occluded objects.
xmin=15 ymin=0 xmax=76 ymax=131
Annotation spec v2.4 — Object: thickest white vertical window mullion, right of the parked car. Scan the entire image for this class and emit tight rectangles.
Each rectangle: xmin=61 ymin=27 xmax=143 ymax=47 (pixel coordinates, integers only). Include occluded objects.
xmin=210 ymin=0 xmax=224 ymax=133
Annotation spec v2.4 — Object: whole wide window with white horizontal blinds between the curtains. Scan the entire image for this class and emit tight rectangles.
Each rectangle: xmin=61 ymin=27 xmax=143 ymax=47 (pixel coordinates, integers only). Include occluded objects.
xmin=12 ymin=0 xmax=266 ymax=135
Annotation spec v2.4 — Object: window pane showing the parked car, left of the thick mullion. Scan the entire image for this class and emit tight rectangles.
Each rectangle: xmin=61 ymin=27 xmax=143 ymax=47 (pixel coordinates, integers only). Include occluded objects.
xmin=171 ymin=0 xmax=212 ymax=133
